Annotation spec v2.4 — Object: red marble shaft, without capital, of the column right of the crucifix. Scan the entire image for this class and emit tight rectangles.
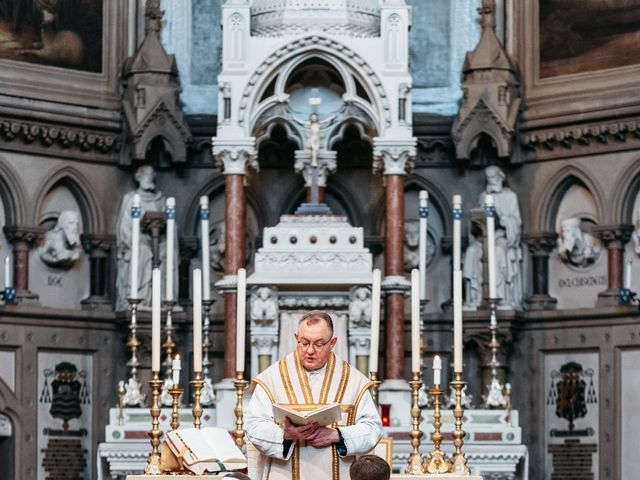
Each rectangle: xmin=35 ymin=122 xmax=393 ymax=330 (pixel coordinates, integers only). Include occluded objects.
xmin=384 ymin=175 xmax=404 ymax=379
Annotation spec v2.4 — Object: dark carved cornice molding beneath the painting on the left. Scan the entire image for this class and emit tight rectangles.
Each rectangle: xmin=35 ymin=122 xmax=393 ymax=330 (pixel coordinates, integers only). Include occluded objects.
xmin=0 ymin=119 xmax=120 ymax=158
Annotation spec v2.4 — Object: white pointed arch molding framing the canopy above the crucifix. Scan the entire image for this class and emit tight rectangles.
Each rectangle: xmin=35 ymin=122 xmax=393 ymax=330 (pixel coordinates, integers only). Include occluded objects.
xmin=238 ymin=35 xmax=391 ymax=126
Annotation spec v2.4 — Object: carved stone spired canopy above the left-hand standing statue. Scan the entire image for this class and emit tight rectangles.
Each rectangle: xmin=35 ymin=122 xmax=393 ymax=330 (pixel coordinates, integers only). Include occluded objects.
xmin=120 ymin=2 xmax=191 ymax=165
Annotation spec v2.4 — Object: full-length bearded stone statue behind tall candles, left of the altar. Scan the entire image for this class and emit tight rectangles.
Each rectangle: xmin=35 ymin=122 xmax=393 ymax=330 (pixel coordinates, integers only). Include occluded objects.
xmin=116 ymin=165 xmax=180 ymax=310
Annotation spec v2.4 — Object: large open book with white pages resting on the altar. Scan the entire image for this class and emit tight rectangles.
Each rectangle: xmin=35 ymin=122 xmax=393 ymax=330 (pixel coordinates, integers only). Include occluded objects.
xmin=162 ymin=427 xmax=247 ymax=475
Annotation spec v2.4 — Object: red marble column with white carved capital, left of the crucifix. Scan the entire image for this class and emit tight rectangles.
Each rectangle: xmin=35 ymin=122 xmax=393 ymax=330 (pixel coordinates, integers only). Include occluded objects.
xmin=213 ymin=138 xmax=258 ymax=378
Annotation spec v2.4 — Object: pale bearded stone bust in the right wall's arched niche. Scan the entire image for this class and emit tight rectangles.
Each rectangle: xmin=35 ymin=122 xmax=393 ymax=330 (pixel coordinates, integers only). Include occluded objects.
xmin=558 ymin=217 xmax=602 ymax=267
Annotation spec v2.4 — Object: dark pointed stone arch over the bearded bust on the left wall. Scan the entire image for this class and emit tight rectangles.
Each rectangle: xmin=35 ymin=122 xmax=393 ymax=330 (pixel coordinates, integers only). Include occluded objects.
xmin=31 ymin=166 xmax=104 ymax=233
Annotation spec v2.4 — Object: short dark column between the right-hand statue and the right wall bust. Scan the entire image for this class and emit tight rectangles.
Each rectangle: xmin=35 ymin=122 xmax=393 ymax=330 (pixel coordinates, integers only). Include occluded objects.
xmin=522 ymin=232 xmax=558 ymax=310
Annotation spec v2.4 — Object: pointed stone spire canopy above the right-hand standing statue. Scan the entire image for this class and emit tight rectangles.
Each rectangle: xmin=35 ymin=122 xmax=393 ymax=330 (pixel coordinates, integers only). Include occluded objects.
xmin=452 ymin=0 xmax=521 ymax=160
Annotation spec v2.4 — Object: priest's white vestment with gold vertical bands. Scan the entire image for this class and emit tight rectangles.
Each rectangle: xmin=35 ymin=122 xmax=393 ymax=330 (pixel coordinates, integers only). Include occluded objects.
xmin=245 ymin=352 xmax=382 ymax=480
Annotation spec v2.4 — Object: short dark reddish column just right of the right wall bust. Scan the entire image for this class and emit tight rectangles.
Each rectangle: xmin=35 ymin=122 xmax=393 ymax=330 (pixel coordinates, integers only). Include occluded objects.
xmin=593 ymin=225 xmax=633 ymax=307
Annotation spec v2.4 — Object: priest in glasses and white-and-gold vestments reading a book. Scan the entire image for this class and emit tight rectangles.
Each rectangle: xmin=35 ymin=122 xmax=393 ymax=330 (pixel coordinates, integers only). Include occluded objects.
xmin=245 ymin=311 xmax=382 ymax=480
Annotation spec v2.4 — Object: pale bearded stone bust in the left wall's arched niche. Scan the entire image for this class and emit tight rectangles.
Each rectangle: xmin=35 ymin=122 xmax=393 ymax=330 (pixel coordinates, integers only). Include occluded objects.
xmin=38 ymin=210 xmax=80 ymax=268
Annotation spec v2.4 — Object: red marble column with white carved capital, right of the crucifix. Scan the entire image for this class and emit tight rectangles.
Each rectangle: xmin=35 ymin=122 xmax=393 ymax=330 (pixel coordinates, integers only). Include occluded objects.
xmin=373 ymin=139 xmax=416 ymax=379
